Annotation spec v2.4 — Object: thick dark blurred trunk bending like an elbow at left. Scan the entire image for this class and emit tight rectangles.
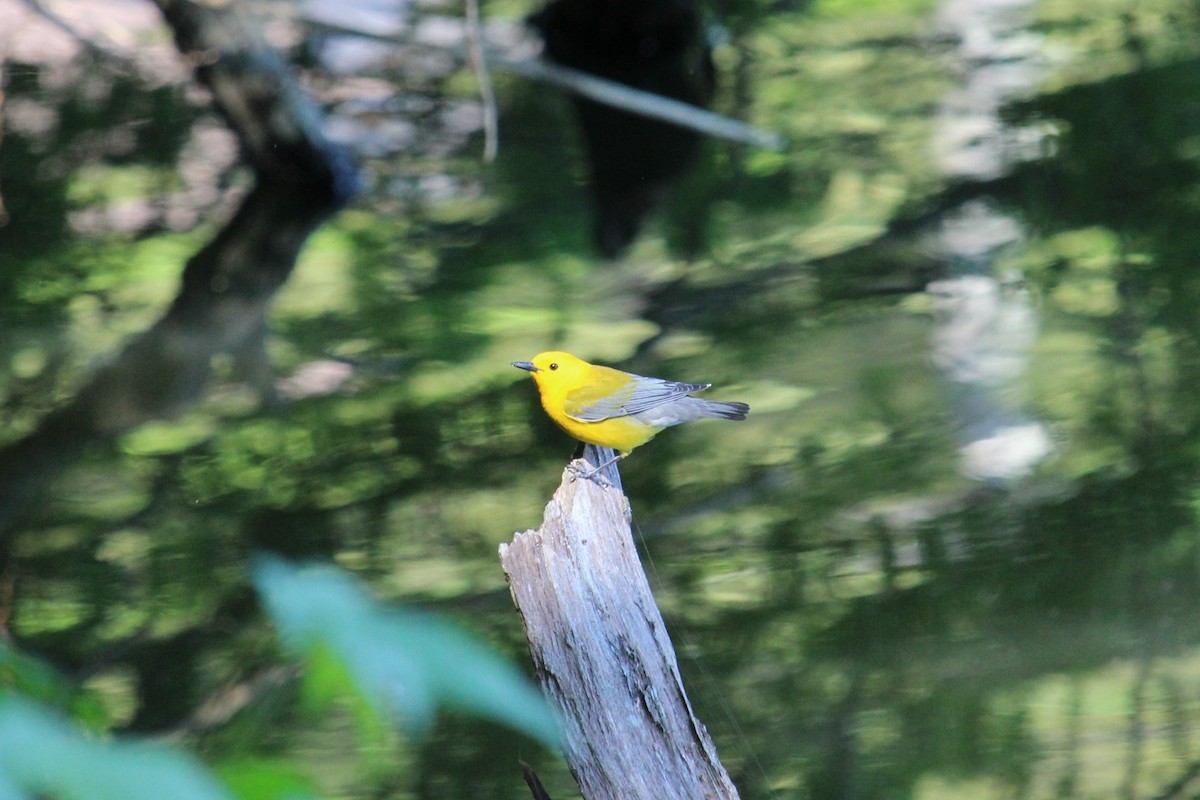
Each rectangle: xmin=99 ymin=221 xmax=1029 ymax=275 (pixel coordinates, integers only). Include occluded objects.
xmin=0 ymin=0 xmax=359 ymax=534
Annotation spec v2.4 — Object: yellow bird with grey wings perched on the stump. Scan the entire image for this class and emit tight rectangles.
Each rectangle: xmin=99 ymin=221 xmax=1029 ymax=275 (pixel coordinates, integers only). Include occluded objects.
xmin=512 ymin=350 xmax=750 ymax=477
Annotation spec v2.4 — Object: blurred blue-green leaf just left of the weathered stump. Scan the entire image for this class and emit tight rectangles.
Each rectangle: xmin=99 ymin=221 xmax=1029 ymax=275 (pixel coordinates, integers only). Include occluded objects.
xmin=254 ymin=557 xmax=558 ymax=748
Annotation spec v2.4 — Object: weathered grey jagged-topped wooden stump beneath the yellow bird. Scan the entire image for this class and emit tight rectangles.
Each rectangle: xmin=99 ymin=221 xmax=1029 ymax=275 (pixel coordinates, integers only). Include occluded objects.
xmin=500 ymin=446 xmax=738 ymax=800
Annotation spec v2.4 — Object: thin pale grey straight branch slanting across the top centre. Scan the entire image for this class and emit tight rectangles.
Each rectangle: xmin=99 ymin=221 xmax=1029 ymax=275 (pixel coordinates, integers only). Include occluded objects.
xmin=300 ymin=19 xmax=787 ymax=150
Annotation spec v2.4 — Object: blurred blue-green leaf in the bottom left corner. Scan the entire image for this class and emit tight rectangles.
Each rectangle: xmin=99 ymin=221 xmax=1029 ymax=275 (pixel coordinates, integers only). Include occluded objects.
xmin=0 ymin=694 xmax=230 ymax=800
